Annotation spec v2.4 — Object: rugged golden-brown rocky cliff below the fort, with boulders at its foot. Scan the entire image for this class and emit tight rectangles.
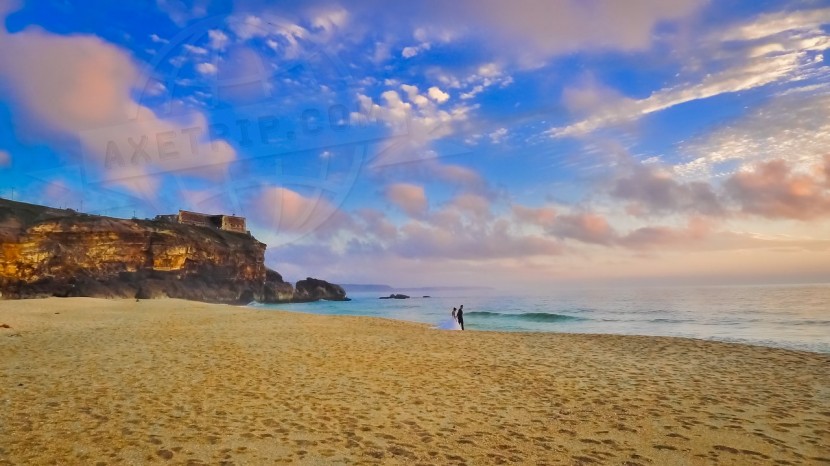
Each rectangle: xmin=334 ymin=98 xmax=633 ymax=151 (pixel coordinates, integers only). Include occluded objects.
xmin=0 ymin=199 xmax=347 ymax=304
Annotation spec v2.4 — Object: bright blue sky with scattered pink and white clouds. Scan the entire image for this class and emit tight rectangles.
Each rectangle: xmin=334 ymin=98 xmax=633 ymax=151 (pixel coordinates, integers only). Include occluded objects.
xmin=0 ymin=0 xmax=830 ymax=291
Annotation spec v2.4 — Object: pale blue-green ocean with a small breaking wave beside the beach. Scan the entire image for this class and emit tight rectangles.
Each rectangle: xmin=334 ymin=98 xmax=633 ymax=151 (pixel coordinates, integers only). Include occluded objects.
xmin=251 ymin=284 xmax=830 ymax=354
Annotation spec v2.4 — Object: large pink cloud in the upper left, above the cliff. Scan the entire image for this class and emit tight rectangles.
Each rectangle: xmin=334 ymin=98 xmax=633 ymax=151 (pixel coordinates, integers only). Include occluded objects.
xmin=0 ymin=10 xmax=236 ymax=197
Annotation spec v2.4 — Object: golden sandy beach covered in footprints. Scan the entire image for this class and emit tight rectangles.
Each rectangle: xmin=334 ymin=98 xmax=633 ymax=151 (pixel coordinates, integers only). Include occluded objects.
xmin=0 ymin=298 xmax=830 ymax=465
